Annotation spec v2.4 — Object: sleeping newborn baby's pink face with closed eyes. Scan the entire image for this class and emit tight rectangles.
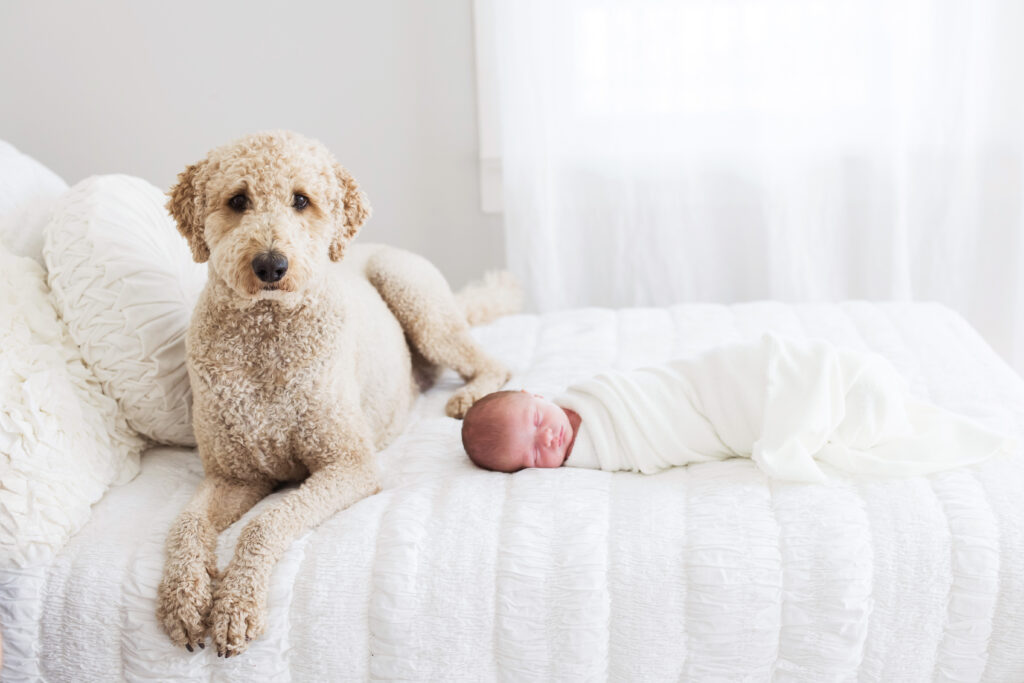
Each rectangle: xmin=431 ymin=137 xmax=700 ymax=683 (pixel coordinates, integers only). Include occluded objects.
xmin=496 ymin=391 xmax=572 ymax=467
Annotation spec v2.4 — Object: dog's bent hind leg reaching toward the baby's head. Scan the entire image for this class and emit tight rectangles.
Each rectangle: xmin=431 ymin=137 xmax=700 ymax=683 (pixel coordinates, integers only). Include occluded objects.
xmin=366 ymin=247 xmax=510 ymax=419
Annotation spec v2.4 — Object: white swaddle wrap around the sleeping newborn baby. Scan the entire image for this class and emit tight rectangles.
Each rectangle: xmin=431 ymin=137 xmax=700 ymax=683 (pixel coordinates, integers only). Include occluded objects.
xmin=554 ymin=334 xmax=1011 ymax=481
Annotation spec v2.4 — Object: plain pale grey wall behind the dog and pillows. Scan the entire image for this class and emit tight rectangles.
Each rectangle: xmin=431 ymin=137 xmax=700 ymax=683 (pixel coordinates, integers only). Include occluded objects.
xmin=0 ymin=0 xmax=505 ymax=287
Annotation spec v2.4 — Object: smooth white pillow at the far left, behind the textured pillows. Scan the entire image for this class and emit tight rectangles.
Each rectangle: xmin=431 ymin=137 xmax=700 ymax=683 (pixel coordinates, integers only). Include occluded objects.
xmin=0 ymin=140 xmax=68 ymax=263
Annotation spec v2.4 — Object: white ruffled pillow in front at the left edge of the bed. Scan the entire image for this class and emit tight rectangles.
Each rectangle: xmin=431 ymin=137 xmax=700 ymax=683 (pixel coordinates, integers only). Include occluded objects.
xmin=0 ymin=245 xmax=143 ymax=569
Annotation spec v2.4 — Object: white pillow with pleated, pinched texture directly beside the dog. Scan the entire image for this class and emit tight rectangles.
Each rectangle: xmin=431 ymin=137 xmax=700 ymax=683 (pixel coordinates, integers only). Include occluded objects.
xmin=43 ymin=175 xmax=206 ymax=445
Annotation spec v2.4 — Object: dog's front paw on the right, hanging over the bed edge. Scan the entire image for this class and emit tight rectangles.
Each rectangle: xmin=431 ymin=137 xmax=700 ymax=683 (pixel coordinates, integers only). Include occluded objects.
xmin=210 ymin=570 xmax=266 ymax=657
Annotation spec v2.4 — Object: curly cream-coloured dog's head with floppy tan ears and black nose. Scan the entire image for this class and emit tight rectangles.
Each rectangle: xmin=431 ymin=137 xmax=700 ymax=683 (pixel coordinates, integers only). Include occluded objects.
xmin=167 ymin=131 xmax=370 ymax=299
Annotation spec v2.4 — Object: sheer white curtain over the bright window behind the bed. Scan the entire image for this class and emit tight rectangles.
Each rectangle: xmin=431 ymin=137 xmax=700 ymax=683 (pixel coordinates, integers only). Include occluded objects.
xmin=484 ymin=0 xmax=1024 ymax=372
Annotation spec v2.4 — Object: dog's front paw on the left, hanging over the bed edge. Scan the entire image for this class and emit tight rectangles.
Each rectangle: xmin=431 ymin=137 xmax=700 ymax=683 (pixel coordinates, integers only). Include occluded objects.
xmin=157 ymin=562 xmax=216 ymax=652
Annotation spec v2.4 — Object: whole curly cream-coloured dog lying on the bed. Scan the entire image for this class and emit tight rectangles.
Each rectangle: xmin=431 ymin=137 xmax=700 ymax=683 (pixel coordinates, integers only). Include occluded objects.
xmin=157 ymin=131 xmax=516 ymax=656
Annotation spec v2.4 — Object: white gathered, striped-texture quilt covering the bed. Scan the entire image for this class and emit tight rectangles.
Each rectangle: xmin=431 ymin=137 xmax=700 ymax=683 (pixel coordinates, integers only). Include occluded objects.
xmin=0 ymin=303 xmax=1024 ymax=682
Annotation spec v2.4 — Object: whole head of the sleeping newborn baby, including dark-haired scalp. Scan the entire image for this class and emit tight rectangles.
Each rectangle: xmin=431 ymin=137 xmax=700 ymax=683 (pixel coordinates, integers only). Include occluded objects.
xmin=462 ymin=391 xmax=574 ymax=472
